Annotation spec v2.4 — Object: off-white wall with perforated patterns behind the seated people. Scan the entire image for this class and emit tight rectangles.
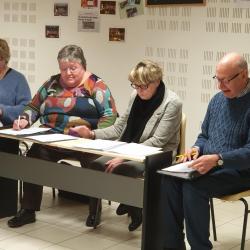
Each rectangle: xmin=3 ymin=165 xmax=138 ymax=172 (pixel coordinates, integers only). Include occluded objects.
xmin=0 ymin=0 xmax=250 ymax=146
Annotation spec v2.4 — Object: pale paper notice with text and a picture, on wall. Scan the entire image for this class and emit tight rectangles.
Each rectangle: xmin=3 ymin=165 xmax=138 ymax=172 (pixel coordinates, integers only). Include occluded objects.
xmin=78 ymin=9 xmax=100 ymax=32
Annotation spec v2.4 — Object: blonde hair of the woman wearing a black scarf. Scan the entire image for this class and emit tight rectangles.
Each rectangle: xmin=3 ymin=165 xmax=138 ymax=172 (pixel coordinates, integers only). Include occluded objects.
xmin=128 ymin=60 xmax=163 ymax=85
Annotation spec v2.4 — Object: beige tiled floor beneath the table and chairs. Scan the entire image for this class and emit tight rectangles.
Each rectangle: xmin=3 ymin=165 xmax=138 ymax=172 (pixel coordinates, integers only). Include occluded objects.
xmin=0 ymin=188 xmax=250 ymax=250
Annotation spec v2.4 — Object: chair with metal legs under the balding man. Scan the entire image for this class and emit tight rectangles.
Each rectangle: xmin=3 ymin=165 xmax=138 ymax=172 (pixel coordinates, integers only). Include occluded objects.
xmin=210 ymin=190 xmax=250 ymax=250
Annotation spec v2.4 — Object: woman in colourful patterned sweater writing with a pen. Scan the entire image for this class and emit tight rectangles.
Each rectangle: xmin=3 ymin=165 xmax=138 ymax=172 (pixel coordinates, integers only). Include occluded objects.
xmin=8 ymin=45 xmax=117 ymax=227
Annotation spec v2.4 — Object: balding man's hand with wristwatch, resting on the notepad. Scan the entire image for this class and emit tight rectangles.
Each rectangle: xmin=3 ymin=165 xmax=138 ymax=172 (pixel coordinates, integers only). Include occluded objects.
xmin=189 ymin=154 xmax=219 ymax=174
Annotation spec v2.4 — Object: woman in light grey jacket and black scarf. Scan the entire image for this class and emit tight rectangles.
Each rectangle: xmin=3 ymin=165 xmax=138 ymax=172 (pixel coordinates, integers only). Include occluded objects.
xmin=71 ymin=60 xmax=182 ymax=231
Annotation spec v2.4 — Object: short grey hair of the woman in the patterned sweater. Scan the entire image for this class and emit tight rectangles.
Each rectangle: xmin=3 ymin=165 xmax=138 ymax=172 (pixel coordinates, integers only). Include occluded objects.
xmin=57 ymin=44 xmax=87 ymax=70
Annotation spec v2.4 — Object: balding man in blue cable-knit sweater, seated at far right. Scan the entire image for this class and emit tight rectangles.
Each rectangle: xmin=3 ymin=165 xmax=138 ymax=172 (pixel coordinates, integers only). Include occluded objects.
xmin=162 ymin=53 xmax=250 ymax=250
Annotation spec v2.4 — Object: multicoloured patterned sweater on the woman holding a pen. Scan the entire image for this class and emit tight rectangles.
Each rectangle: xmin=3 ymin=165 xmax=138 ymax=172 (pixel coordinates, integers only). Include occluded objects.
xmin=22 ymin=74 xmax=117 ymax=134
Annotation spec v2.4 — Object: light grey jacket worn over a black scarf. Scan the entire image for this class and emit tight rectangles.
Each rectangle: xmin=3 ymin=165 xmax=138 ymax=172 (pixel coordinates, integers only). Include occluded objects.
xmin=94 ymin=87 xmax=182 ymax=155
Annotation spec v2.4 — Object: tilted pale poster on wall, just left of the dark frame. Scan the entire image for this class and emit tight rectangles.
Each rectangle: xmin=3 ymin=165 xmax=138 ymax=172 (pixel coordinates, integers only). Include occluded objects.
xmin=118 ymin=0 xmax=144 ymax=19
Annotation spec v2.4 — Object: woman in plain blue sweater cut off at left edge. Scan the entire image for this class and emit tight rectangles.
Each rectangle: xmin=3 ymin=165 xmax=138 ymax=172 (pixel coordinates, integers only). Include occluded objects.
xmin=0 ymin=39 xmax=31 ymax=217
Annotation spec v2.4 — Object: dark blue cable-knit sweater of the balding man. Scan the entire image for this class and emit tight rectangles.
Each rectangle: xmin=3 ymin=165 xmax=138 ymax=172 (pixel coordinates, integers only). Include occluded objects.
xmin=195 ymin=92 xmax=250 ymax=172
